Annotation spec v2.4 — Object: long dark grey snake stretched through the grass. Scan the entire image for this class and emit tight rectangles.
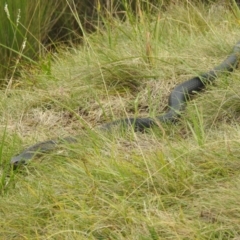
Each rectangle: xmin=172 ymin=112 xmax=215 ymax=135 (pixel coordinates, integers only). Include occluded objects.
xmin=10 ymin=41 xmax=240 ymax=167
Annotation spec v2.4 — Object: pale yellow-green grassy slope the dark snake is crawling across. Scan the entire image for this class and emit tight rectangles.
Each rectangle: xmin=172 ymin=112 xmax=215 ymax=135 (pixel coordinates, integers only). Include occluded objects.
xmin=0 ymin=1 xmax=240 ymax=239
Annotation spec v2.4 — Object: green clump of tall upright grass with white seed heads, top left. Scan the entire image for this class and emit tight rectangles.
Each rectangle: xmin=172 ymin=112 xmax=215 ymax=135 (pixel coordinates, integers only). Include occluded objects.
xmin=0 ymin=0 xmax=66 ymax=85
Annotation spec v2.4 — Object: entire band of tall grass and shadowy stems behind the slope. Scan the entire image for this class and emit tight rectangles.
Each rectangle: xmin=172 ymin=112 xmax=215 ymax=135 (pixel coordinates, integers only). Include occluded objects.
xmin=0 ymin=0 xmax=227 ymax=86
